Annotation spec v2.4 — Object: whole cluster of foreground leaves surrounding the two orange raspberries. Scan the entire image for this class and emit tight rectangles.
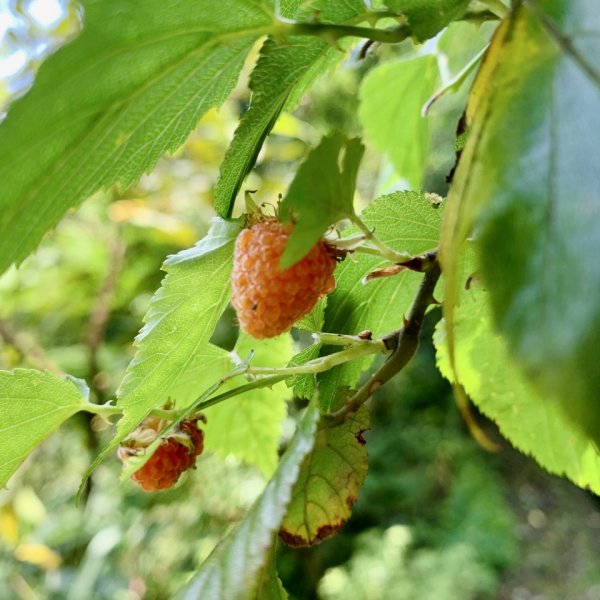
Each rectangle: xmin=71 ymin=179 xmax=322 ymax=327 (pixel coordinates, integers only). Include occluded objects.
xmin=0 ymin=0 xmax=600 ymax=598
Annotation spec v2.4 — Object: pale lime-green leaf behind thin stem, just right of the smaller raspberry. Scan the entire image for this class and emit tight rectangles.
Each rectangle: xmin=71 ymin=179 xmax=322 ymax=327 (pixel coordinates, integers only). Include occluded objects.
xmin=204 ymin=333 xmax=293 ymax=477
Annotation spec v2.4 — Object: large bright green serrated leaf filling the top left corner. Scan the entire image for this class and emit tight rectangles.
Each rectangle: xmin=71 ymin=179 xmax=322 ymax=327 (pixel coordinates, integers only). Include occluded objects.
xmin=0 ymin=0 xmax=273 ymax=272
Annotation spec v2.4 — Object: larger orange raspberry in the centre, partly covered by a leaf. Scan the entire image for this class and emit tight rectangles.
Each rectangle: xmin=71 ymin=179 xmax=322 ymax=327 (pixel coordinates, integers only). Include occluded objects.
xmin=231 ymin=219 xmax=337 ymax=338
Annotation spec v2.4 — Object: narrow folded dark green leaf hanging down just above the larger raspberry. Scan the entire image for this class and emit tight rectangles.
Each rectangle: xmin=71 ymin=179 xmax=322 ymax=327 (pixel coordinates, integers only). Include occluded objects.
xmin=215 ymin=0 xmax=365 ymax=217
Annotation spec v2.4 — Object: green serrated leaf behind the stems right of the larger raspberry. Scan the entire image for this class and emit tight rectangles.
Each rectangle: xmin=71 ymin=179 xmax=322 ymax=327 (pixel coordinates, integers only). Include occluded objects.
xmin=319 ymin=192 xmax=443 ymax=411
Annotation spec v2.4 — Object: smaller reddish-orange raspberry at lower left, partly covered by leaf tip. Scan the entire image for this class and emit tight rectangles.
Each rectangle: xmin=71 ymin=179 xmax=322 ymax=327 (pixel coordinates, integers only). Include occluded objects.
xmin=118 ymin=417 xmax=204 ymax=492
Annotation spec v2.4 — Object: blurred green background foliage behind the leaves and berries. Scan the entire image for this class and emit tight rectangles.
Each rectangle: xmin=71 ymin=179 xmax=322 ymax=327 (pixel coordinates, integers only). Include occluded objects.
xmin=0 ymin=4 xmax=600 ymax=600
